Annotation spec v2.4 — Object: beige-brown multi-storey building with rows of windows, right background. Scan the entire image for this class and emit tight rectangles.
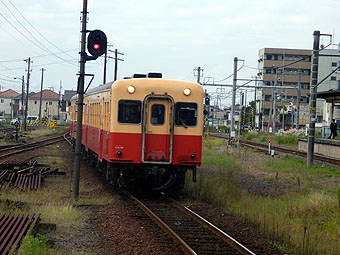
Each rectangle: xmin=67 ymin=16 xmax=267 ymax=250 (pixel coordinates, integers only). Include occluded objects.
xmin=255 ymin=48 xmax=312 ymax=130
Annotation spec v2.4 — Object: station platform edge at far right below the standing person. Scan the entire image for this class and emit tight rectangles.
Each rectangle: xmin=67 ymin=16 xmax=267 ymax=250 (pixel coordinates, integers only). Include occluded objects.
xmin=298 ymin=138 xmax=340 ymax=159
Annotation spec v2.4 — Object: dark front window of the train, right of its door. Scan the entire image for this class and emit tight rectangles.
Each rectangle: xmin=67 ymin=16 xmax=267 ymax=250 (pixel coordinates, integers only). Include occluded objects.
xmin=175 ymin=103 xmax=197 ymax=127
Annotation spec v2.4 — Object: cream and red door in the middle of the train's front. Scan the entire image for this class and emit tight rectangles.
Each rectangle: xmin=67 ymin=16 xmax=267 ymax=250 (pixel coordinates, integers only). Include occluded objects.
xmin=142 ymin=96 xmax=174 ymax=164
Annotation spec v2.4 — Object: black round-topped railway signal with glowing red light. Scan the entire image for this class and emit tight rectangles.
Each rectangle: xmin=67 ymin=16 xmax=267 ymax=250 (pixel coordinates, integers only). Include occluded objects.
xmin=87 ymin=30 xmax=107 ymax=60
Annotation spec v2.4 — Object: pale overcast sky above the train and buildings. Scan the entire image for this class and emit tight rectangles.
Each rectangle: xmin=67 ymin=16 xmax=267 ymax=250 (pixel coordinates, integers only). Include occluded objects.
xmin=0 ymin=0 xmax=340 ymax=105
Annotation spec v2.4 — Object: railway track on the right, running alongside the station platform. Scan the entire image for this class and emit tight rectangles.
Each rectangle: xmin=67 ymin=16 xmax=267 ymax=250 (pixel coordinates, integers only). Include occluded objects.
xmin=210 ymin=134 xmax=340 ymax=165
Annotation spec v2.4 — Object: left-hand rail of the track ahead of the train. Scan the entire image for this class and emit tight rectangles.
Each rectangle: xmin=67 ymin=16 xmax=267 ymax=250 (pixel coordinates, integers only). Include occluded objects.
xmin=129 ymin=195 xmax=197 ymax=255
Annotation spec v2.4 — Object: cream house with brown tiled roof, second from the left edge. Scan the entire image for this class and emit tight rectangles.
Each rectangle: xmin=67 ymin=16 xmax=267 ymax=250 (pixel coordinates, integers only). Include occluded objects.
xmin=27 ymin=89 xmax=59 ymax=120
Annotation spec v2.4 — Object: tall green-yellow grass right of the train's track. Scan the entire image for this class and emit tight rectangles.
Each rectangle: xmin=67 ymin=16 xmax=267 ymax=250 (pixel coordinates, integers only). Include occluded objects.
xmin=185 ymin=138 xmax=340 ymax=255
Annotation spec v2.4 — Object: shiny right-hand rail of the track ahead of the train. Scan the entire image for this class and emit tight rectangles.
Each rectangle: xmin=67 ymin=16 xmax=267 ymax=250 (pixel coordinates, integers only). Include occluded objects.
xmin=171 ymin=199 xmax=256 ymax=255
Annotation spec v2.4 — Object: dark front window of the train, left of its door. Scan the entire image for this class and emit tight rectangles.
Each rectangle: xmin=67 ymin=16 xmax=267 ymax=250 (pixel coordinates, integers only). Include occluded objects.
xmin=118 ymin=100 xmax=142 ymax=124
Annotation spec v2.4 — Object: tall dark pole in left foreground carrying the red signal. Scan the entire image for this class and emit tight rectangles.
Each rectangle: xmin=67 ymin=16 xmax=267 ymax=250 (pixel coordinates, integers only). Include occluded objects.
xmin=73 ymin=0 xmax=87 ymax=200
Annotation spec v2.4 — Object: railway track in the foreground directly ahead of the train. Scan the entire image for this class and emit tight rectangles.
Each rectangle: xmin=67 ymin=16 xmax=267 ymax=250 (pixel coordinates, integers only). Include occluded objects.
xmin=130 ymin=195 xmax=255 ymax=255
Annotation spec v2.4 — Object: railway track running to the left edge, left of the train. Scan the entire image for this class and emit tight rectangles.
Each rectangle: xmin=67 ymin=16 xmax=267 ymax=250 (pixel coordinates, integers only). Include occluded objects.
xmin=0 ymin=133 xmax=68 ymax=159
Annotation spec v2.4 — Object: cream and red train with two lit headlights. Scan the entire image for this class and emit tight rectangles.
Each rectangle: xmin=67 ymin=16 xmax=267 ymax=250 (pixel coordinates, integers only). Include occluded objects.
xmin=70 ymin=74 xmax=204 ymax=192
